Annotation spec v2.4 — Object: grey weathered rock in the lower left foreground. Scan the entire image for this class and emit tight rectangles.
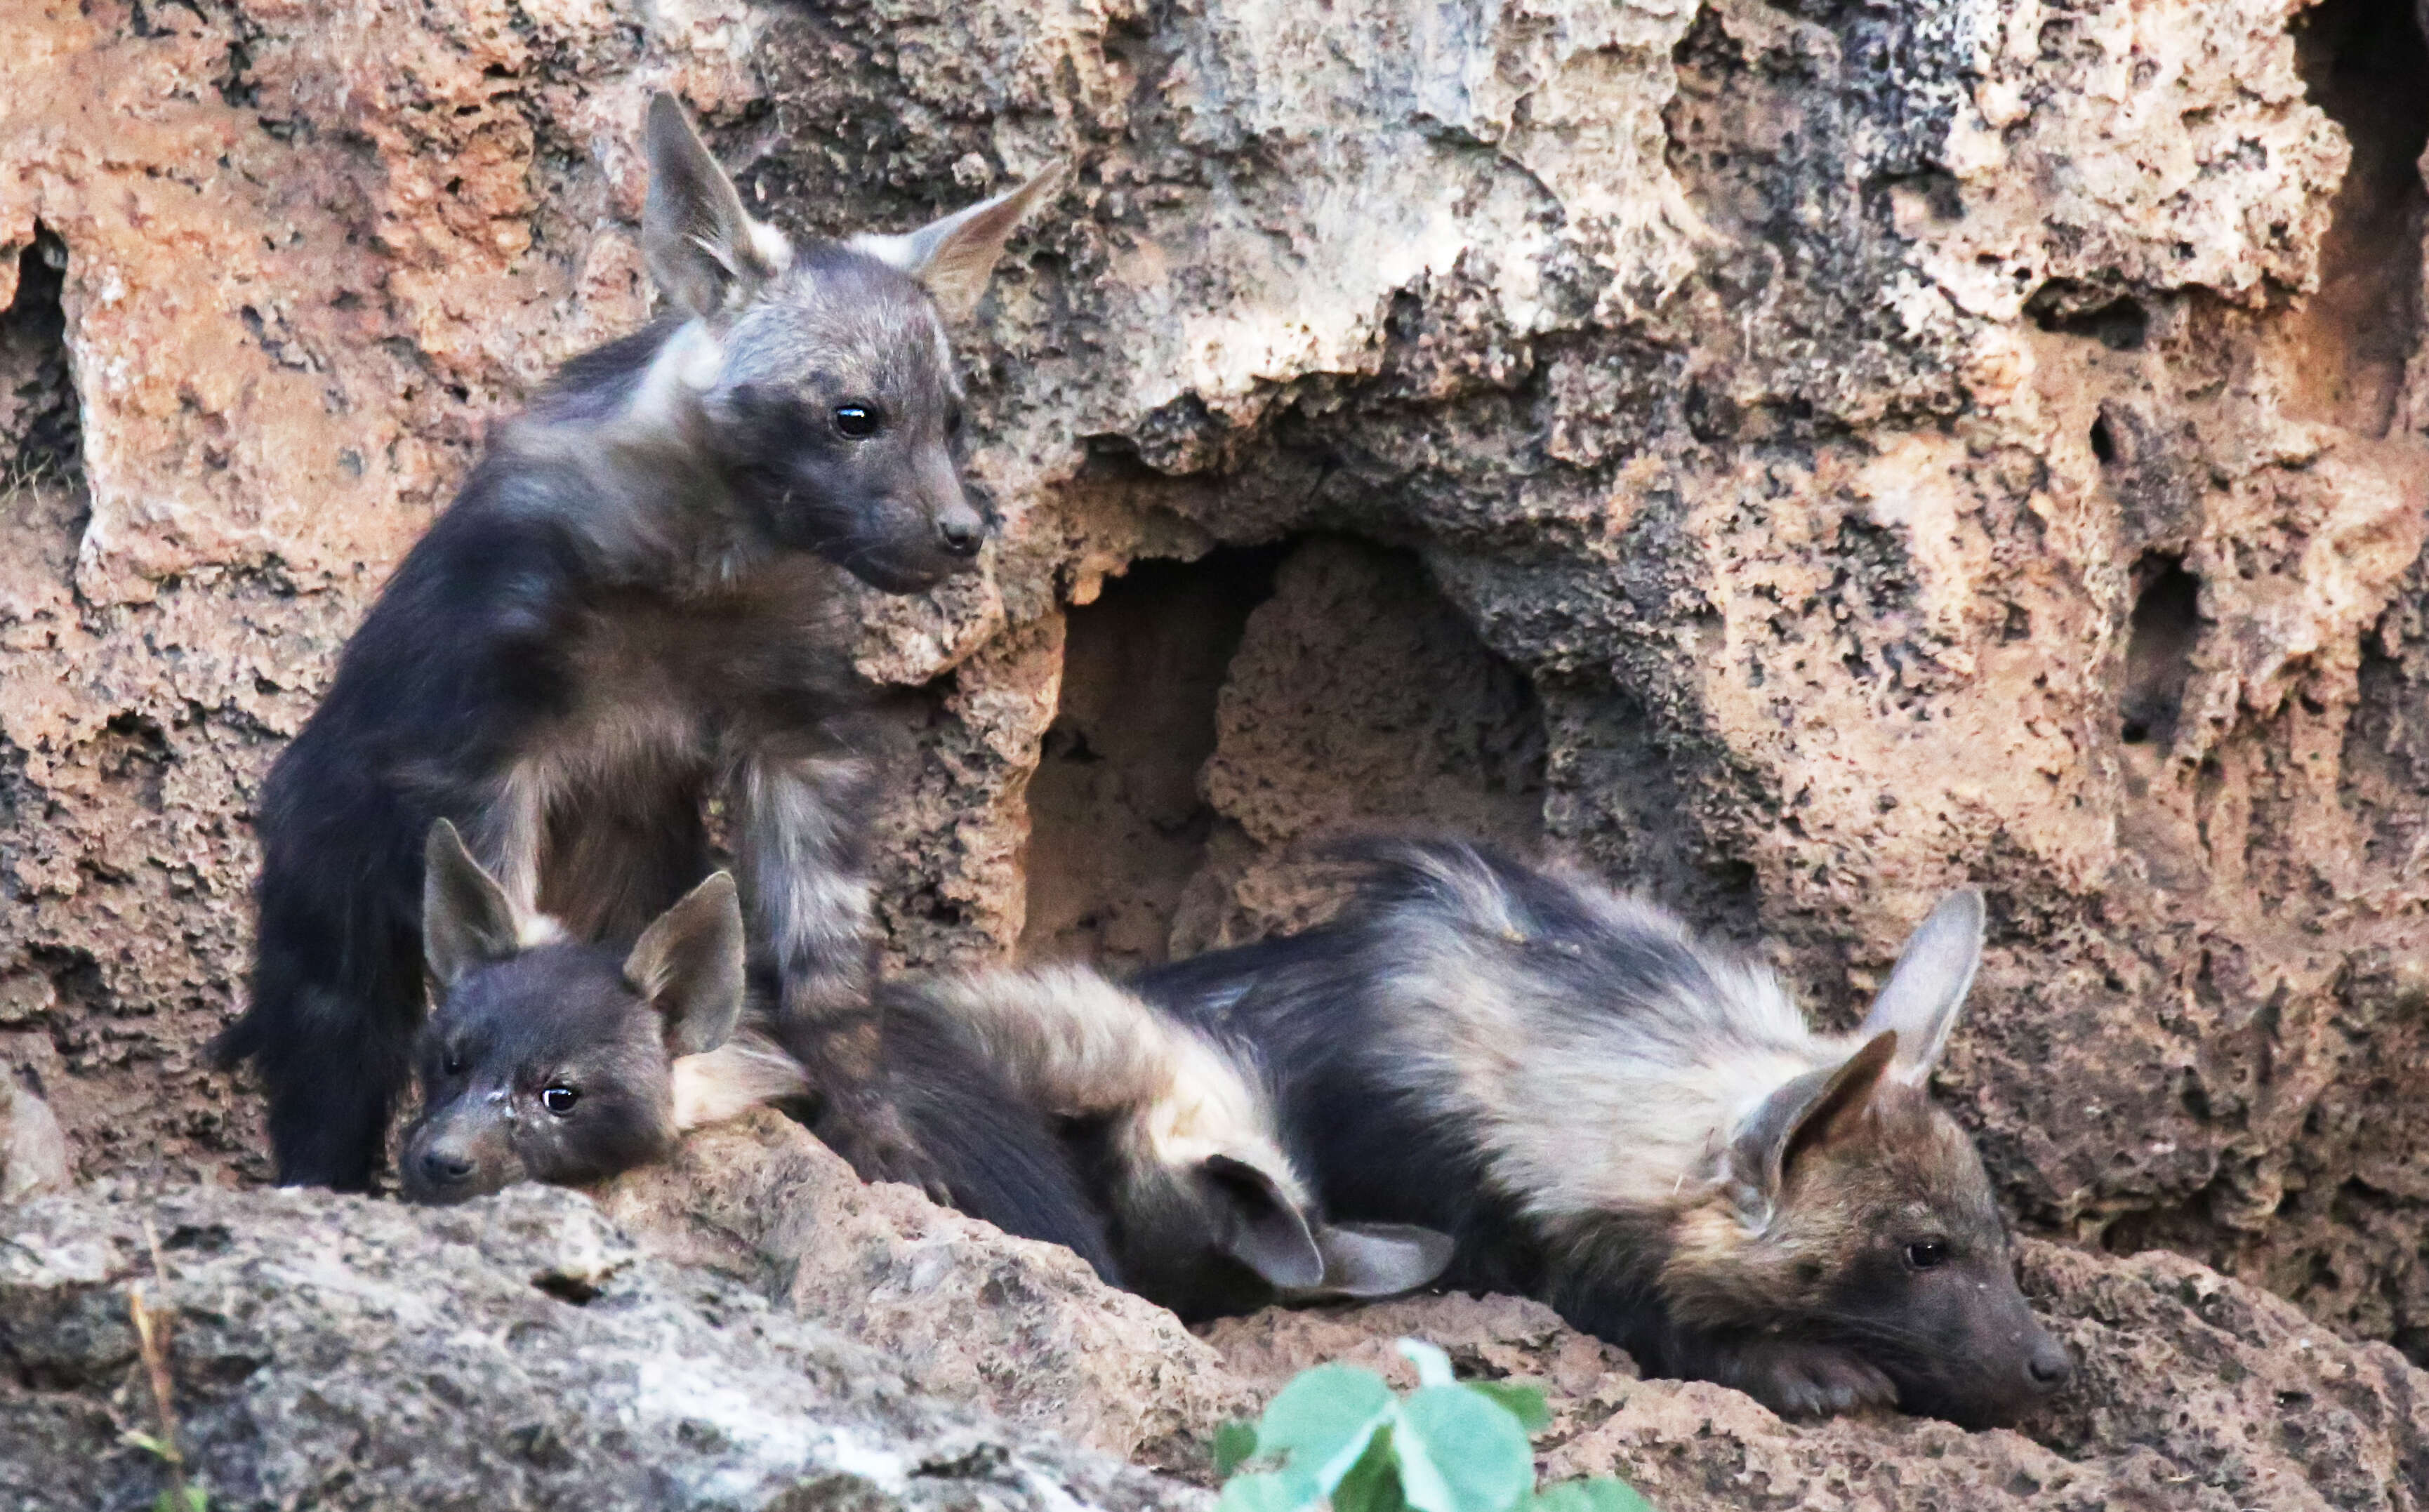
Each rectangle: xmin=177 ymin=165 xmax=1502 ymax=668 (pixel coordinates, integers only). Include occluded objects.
xmin=0 ymin=1187 xmax=1203 ymax=1512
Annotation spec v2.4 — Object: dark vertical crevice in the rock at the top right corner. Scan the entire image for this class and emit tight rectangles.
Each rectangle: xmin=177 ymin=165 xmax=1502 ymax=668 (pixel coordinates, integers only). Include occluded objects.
xmin=2293 ymin=0 xmax=2429 ymax=437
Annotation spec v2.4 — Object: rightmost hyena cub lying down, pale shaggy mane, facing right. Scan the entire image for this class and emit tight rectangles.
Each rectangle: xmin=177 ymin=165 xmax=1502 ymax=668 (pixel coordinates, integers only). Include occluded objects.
xmin=1141 ymin=842 xmax=2072 ymax=1425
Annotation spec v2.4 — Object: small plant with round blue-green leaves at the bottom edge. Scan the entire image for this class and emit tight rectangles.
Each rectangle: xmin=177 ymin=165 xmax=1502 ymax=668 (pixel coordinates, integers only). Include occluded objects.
xmin=1214 ymin=1340 xmax=1652 ymax=1512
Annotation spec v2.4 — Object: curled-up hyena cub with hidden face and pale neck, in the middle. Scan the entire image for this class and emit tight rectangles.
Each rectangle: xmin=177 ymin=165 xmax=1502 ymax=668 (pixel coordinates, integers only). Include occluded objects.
xmin=908 ymin=966 xmax=1450 ymax=1320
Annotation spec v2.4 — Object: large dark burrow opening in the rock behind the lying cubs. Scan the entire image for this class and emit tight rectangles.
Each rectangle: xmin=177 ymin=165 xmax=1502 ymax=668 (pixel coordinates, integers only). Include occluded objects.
xmin=1020 ymin=536 xmax=1545 ymax=969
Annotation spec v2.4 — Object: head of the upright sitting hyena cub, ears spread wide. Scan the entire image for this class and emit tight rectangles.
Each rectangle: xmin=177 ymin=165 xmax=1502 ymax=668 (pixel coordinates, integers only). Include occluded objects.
xmin=641 ymin=95 xmax=1061 ymax=592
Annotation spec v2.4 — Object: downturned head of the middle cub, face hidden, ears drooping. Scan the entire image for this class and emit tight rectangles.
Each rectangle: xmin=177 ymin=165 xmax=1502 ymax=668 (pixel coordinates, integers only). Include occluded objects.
xmin=1098 ymin=1039 xmax=1452 ymax=1318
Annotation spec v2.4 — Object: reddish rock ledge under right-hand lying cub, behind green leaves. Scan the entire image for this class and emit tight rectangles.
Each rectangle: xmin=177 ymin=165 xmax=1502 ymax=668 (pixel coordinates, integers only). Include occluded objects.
xmin=1212 ymin=1245 xmax=2429 ymax=1512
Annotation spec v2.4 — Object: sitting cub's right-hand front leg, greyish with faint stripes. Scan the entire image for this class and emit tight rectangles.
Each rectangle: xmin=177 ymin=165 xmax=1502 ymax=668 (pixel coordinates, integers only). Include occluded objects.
xmin=731 ymin=741 xmax=942 ymax=1201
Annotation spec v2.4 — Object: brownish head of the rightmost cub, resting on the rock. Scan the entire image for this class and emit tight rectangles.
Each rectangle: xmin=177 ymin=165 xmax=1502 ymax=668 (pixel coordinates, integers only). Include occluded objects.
xmin=1659 ymin=891 xmax=2072 ymax=1427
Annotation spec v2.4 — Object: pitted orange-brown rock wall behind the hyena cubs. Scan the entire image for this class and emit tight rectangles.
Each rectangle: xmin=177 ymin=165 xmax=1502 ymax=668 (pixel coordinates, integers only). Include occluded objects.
xmin=0 ymin=0 xmax=2429 ymax=1388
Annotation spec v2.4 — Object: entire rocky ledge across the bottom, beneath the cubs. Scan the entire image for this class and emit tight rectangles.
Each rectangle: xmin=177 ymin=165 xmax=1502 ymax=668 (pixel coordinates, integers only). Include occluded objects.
xmin=0 ymin=1121 xmax=2429 ymax=1512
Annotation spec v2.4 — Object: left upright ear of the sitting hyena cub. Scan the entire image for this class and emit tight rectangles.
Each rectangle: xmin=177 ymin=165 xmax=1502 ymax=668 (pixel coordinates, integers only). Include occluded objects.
xmin=641 ymin=92 xmax=792 ymax=315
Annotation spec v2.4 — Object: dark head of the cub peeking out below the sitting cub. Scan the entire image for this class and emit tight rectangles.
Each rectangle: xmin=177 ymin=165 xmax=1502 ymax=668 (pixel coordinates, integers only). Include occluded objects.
xmin=398 ymin=821 xmax=743 ymax=1201
